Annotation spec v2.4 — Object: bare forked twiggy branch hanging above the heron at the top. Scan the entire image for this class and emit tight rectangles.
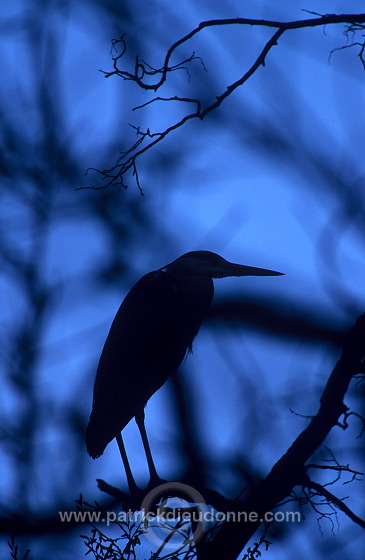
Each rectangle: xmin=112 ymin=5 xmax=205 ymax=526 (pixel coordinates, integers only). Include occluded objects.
xmin=84 ymin=12 xmax=365 ymax=194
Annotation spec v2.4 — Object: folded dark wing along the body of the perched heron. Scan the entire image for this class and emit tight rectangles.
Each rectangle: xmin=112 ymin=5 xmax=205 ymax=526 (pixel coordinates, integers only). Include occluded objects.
xmin=86 ymin=271 xmax=183 ymax=457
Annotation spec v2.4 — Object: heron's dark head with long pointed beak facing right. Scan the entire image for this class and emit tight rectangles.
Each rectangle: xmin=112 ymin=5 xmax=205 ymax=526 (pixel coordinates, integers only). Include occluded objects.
xmin=161 ymin=251 xmax=283 ymax=278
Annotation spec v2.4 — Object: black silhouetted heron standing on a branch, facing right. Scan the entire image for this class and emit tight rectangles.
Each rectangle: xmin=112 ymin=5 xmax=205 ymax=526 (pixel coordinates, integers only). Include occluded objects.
xmin=86 ymin=251 xmax=282 ymax=492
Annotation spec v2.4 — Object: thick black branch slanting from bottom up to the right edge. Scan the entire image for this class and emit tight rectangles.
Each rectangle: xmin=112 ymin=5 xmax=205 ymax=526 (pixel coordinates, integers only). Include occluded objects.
xmin=198 ymin=314 xmax=365 ymax=560
